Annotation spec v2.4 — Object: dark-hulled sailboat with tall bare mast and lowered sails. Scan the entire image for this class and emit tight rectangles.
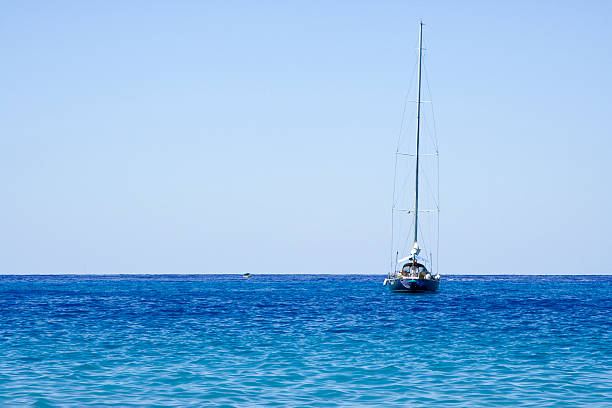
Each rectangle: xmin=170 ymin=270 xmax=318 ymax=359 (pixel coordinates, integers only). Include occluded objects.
xmin=383 ymin=22 xmax=440 ymax=293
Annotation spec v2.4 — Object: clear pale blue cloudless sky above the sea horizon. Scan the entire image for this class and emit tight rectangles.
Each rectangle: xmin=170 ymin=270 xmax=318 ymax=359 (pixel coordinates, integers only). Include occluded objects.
xmin=0 ymin=1 xmax=612 ymax=275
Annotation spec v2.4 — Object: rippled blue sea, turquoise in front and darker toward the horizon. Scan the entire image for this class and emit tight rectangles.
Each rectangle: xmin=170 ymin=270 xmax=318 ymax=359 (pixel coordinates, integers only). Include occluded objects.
xmin=0 ymin=275 xmax=612 ymax=407
